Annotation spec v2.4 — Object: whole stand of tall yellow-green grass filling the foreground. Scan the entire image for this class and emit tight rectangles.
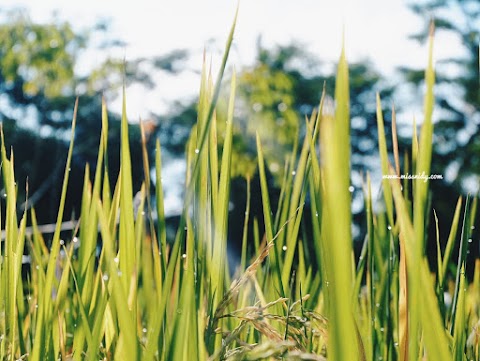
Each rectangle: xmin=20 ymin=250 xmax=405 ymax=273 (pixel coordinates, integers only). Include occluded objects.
xmin=0 ymin=12 xmax=480 ymax=361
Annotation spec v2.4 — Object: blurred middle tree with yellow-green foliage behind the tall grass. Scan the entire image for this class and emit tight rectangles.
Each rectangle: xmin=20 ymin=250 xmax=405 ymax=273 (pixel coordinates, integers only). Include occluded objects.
xmin=158 ymin=42 xmax=392 ymax=253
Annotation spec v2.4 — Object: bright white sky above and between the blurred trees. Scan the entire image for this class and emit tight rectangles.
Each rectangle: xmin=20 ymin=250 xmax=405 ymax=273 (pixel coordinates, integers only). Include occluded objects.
xmin=2 ymin=0 xmax=438 ymax=119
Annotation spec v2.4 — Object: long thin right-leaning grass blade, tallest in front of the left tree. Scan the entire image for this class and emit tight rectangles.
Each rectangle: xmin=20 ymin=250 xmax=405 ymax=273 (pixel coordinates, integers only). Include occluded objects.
xmin=30 ymin=99 xmax=78 ymax=361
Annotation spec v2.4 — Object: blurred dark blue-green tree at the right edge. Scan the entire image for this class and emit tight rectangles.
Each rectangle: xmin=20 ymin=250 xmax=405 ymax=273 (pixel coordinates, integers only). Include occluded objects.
xmin=400 ymin=0 xmax=480 ymax=274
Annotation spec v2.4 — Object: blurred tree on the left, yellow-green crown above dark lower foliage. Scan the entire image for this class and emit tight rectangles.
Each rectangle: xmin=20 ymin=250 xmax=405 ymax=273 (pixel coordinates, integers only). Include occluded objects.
xmin=0 ymin=9 xmax=188 ymax=222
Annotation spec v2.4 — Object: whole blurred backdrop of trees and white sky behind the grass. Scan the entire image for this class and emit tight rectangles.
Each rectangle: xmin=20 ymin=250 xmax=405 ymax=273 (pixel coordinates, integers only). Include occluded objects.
xmin=0 ymin=0 xmax=480 ymax=268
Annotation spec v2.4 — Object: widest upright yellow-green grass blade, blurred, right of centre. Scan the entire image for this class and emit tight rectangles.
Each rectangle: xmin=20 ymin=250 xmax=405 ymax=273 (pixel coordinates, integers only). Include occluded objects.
xmin=320 ymin=43 xmax=359 ymax=361
